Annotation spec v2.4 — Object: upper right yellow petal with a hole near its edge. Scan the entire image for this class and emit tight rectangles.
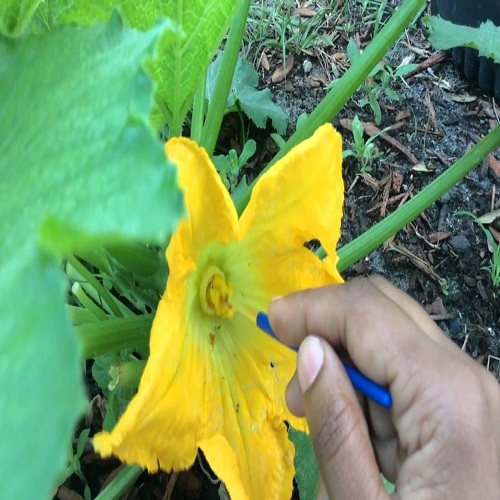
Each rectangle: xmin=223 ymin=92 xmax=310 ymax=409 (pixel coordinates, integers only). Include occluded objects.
xmin=233 ymin=124 xmax=344 ymax=299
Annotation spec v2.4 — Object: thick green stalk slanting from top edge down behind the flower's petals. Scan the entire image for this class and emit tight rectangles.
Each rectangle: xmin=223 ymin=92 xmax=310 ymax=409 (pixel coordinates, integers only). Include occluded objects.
xmin=235 ymin=0 xmax=426 ymax=214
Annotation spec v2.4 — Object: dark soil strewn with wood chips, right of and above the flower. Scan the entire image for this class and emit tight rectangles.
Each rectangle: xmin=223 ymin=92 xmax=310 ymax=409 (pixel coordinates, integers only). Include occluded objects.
xmin=261 ymin=1 xmax=500 ymax=368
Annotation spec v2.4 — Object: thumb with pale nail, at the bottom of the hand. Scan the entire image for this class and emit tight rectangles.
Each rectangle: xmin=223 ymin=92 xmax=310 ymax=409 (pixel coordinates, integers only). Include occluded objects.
xmin=297 ymin=336 xmax=387 ymax=498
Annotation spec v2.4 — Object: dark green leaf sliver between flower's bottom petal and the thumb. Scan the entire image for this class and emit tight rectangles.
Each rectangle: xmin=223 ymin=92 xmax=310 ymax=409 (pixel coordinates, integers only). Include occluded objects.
xmin=288 ymin=427 xmax=319 ymax=500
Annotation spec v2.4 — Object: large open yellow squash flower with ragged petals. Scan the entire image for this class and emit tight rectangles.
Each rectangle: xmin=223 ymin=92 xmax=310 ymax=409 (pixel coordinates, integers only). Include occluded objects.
xmin=94 ymin=125 xmax=343 ymax=499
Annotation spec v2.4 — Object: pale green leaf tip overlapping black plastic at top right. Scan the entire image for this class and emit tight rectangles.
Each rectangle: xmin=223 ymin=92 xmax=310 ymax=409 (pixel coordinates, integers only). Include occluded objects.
xmin=428 ymin=16 xmax=500 ymax=63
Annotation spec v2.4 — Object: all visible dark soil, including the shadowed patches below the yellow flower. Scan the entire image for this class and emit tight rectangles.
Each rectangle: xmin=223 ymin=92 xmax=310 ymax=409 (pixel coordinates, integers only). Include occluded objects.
xmin=57 ymin=1 xmax=500 ymax=499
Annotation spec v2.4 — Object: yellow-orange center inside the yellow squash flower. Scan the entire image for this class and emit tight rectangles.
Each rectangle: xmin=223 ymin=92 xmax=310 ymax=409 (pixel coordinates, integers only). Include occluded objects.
xmin=200 ymin=266 xmax=234 ymax=318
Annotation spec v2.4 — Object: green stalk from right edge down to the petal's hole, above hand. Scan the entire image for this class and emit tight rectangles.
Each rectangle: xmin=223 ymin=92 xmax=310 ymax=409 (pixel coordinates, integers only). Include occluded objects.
xmin=334 ymin=126 xmax=500 ymax=272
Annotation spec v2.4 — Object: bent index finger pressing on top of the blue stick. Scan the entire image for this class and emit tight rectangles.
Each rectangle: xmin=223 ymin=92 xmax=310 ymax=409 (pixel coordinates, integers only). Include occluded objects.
xmin=268 ymin=279 xmax=461 ymax=406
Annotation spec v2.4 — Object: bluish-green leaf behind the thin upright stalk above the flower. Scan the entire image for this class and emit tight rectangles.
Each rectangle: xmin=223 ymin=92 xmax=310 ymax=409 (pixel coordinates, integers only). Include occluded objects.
xmin=206 ymin=54 xmax=288 ymax=135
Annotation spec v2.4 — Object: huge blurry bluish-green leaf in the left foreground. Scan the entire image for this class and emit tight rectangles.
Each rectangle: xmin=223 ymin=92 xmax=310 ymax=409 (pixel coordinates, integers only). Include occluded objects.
xmin=0 ymin=17 xmax=183 ymax=498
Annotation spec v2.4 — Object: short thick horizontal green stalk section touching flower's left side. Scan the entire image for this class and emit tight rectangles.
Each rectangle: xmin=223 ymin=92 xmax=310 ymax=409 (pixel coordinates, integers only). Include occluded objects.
xmin=75 ymin=314 xmax=153 ymax=359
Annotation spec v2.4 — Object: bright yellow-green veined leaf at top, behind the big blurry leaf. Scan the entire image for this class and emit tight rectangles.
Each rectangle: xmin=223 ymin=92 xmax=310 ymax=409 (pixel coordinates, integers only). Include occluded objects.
xmin=55 ymin=0 xmax=240 ymax=134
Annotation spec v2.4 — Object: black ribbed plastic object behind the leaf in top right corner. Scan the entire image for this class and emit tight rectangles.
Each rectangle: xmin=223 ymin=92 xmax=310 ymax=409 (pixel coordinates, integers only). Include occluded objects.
xmin=431 ymin=0 xmax=500 ymax=100
